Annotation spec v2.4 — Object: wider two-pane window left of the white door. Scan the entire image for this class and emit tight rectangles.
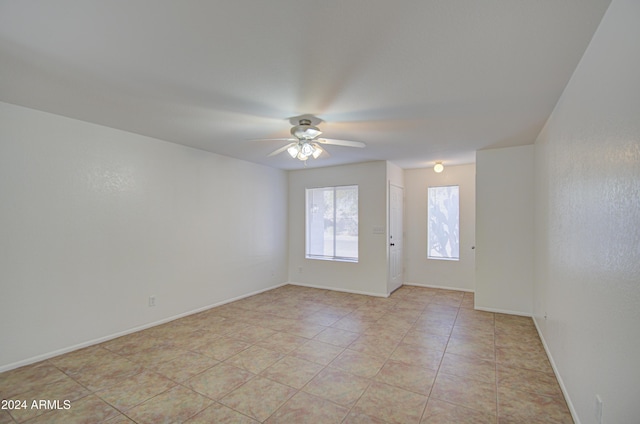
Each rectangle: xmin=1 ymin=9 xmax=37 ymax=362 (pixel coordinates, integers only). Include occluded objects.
xmin=306 ymin=186 xmax=358 ymax=262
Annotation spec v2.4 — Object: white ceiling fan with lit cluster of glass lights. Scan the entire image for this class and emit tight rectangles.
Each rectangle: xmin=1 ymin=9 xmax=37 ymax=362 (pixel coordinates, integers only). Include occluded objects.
xmin=254 ymin=117 xmax=366 ymax=161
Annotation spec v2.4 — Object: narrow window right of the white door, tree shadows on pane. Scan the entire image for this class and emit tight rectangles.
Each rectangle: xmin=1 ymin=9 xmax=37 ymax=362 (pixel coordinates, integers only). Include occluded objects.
xmin=427 ymin=186 xmax=460 ymax=261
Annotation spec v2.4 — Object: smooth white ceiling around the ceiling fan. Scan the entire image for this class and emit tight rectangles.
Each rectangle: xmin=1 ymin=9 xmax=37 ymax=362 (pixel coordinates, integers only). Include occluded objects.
xmin=0 ymin=0 xmax=610 ymax=169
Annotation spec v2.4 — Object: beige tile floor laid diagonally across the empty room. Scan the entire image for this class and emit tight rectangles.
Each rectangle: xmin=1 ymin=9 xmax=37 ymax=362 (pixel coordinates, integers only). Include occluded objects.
xmin=0 ymin=286 xmax=573 ymax=424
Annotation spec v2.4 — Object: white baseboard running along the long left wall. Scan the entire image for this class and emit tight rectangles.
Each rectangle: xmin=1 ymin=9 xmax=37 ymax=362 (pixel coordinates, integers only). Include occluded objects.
xmin=0 ymin=283 xmax=289 ymax=372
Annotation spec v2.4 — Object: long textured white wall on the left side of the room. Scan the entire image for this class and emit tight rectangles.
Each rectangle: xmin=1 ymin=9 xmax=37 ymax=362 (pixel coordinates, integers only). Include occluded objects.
xmin=0 ymin=103 xmax=287 ymax=369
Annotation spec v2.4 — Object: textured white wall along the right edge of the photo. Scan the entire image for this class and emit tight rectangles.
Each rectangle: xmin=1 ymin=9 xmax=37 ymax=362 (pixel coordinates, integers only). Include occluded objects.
xmin=534 ymin=0 xmax=640 ymax=424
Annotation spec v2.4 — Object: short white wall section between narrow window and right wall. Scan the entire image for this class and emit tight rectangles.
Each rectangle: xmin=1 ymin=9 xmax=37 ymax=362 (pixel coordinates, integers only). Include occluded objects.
xmin=475 ymin=145 xmax=534 ymax=315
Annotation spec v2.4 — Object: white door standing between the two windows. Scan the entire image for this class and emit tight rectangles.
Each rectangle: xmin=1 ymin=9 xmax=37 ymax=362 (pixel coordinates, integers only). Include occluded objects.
xmin=387 ymin=184 xmax=404 ymax=293
